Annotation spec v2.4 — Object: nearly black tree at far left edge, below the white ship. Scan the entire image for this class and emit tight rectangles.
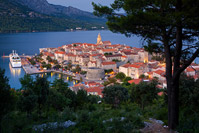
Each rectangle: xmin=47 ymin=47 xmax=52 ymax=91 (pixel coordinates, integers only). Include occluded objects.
xmin=0 ymin=68 xmax=15 ymax=132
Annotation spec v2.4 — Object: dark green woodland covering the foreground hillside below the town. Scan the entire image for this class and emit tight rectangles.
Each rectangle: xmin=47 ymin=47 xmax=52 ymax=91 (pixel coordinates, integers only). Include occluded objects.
xmin=0 ymin=69 xmax=199 ymax=132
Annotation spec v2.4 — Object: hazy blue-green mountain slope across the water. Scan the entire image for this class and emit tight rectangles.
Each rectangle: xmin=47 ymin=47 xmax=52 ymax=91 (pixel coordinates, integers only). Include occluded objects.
xmin=0 ymin=0 xmax=105 ymax=32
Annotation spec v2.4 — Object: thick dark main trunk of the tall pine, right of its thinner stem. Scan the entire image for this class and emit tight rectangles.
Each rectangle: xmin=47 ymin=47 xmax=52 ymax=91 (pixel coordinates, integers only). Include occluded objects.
xmin=167 ymin=0 xmax=182 ymax=129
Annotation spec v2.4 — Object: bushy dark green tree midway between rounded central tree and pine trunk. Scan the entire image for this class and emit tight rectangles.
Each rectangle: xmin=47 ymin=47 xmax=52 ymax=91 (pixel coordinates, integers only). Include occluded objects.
xmin=131 ymin=80 xmax=159 ymax=109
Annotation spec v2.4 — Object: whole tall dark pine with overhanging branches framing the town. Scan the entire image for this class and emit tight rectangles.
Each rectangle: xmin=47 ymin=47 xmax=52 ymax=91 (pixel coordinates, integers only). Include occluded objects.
xmin=93 ymin=0 xmax=199 ymax=129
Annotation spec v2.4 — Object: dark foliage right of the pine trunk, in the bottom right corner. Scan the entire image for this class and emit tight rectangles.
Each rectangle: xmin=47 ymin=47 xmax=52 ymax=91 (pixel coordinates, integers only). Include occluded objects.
xmin=178 ymin=75 xmax=199 ymax=132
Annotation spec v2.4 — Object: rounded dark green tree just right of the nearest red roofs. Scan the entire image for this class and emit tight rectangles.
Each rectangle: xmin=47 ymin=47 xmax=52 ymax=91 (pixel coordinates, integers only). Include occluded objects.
xmin=102 ymin=85 xmax=129 ymax=108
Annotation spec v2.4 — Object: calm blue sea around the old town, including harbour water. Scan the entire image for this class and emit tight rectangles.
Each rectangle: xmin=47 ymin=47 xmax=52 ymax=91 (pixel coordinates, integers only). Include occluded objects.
xmin=0 ymin=31 xmax=142 ymax=89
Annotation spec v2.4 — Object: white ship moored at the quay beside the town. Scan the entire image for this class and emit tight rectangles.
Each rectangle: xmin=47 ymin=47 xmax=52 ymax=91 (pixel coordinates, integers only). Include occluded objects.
xmin=9 ymin=50 xmax=21 ymax=68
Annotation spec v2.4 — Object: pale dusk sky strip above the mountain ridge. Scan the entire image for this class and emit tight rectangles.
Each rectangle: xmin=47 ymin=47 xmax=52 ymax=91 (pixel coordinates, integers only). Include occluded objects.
xmin=47 ymin=0 xmax=114 ymax=12
